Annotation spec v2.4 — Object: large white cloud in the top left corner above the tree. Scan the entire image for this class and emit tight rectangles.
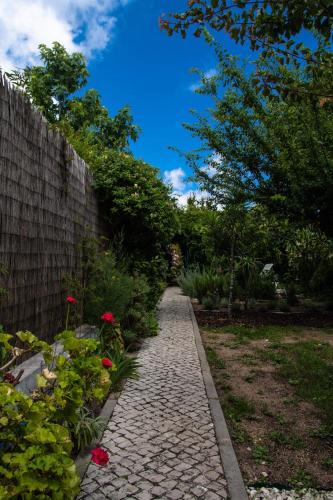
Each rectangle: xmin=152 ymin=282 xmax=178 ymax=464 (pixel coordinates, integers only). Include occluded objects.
xmin=0 ymin=0 xmax=129 ymax=70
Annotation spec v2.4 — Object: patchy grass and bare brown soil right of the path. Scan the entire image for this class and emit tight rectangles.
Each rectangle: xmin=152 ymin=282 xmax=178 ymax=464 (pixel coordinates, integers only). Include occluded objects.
xmin=197 ymin=324 xmax=333 ymax=490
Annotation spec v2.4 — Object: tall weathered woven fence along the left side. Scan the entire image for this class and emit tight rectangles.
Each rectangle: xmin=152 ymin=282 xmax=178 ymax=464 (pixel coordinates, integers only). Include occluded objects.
xmin=0 ymin=74 xmax=104 ymax=340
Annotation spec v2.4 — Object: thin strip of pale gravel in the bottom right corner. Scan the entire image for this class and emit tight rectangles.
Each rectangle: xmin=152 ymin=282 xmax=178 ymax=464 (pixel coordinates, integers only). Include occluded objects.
xmin=247 ymin=488 xmax=333 ymax=500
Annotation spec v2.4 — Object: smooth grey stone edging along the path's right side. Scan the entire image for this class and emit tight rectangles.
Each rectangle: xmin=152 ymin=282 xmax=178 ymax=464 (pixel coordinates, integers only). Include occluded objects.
xmin=188 ymin=298 xmax=248 ymax=500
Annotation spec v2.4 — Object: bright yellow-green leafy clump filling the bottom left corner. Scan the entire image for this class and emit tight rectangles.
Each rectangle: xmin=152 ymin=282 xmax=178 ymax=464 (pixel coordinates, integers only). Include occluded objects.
xmin=0 ymin=383 xmax=79 ymax=500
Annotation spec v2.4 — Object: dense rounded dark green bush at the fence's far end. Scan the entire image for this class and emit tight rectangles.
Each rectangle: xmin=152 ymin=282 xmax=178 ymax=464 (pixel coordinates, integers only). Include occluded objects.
xmin=90 ymin=150 xmax=175 ymax=261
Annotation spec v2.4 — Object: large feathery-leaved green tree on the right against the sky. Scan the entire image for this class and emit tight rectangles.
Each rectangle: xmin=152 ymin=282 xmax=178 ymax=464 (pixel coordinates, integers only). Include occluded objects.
xmin=185 ymin=41 xmax=333 ymax=235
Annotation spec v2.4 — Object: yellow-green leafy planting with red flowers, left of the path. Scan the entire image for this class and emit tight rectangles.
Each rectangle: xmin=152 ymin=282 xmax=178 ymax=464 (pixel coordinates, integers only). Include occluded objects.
xmin=0 ymin=296 xmax=138 ymax=500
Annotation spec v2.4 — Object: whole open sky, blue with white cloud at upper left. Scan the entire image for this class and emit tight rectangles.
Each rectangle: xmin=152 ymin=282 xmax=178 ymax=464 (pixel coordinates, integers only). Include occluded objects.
xmin=0 ymin=0 xmax=312 ymax=202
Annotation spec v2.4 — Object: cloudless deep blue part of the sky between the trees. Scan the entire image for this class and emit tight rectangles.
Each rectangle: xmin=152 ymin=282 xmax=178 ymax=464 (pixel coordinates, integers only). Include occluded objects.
xmin=85 ymin=0 xmax=249 ymax=199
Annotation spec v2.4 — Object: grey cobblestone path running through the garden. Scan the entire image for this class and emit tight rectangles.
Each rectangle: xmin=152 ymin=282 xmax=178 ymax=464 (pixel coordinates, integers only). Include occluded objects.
xmin=79 ymin=288 xmax=227 ymax=500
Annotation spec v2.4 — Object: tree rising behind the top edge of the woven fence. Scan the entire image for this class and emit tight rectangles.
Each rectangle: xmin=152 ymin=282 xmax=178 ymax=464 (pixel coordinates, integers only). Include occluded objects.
xmin=7 ymin=42 xmax=140 ymax=151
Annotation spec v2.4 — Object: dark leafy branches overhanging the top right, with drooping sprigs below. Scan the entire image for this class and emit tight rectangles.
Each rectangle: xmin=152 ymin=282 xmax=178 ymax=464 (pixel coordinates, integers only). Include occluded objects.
xmin=160 ymin=0 xmax=333 ymax=98
